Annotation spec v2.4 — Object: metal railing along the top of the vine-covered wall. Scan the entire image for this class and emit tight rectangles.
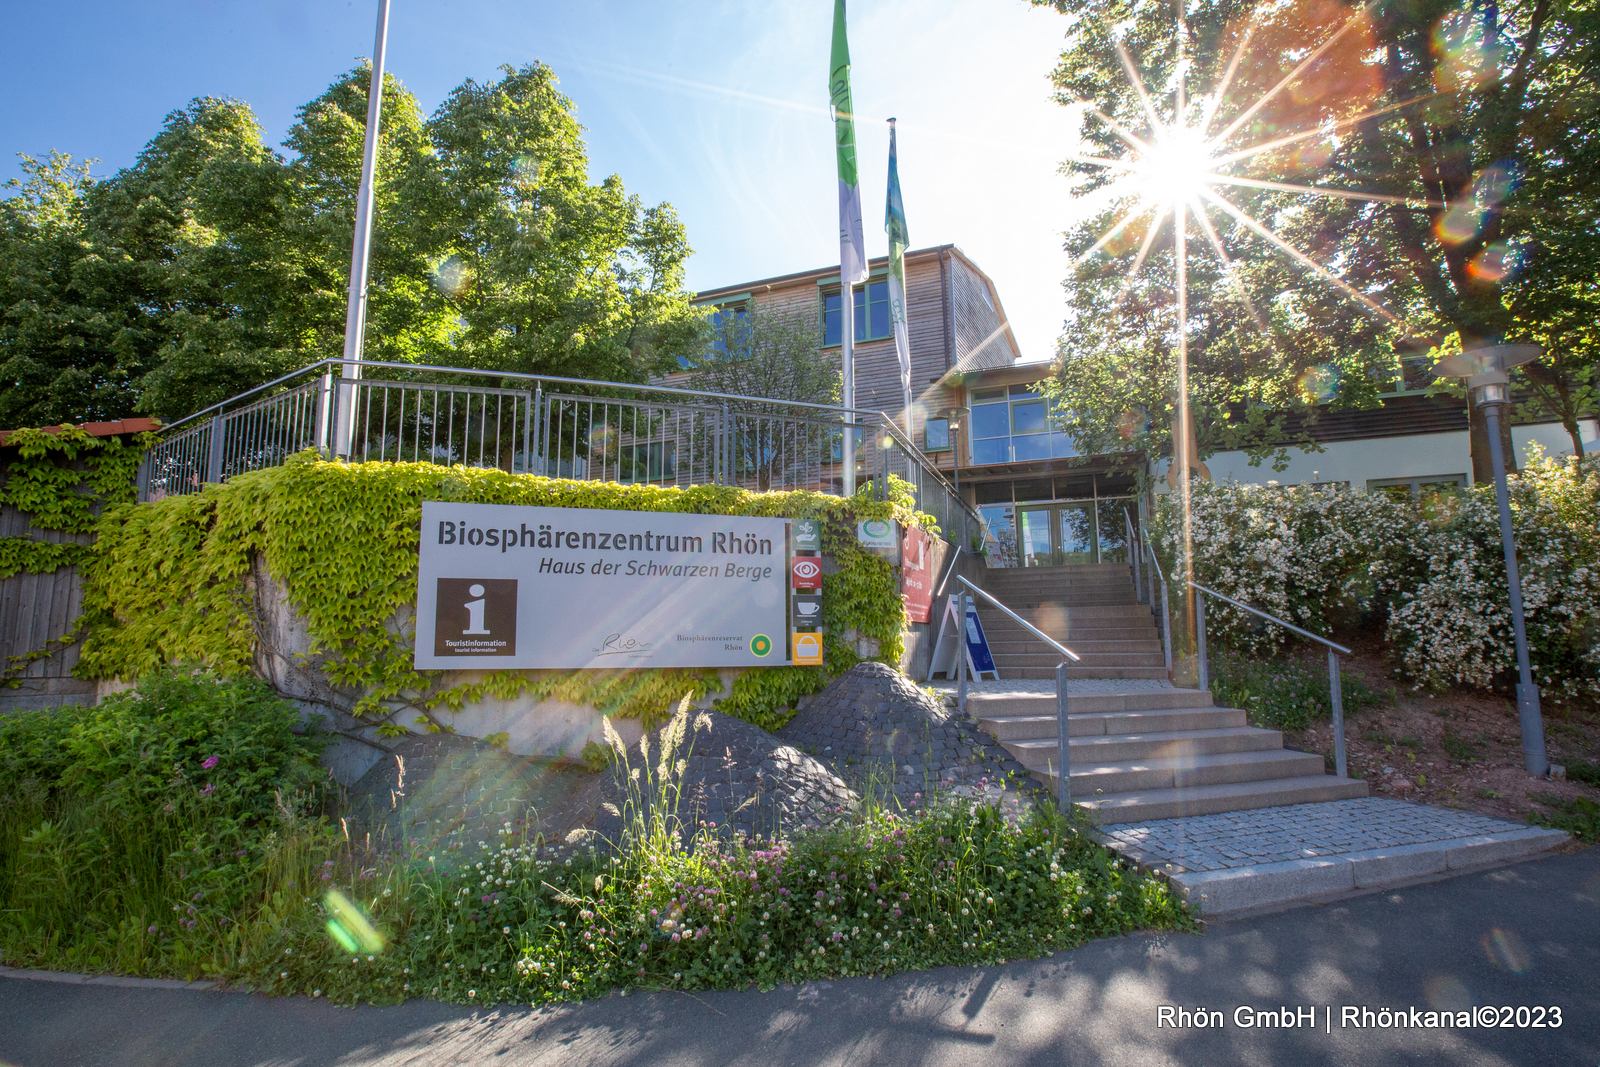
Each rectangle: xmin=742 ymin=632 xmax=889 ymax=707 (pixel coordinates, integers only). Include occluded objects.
xmin=139 ymin=360 xmax=981 ymax=545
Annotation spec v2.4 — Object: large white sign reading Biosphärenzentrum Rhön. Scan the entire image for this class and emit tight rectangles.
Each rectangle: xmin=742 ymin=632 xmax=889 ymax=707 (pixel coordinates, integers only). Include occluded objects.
xmin=416 ymin=501 xmax=790 ymax=669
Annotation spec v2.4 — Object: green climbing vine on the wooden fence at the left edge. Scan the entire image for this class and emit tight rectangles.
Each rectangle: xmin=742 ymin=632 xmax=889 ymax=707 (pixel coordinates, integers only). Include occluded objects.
xmin=0 ymin=426 xmax=147 ymax=688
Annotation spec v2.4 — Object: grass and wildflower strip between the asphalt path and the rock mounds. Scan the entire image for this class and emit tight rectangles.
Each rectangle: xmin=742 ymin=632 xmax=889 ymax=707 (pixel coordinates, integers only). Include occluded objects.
xmin=0 ymin=681 xmax=1192 ymax=1005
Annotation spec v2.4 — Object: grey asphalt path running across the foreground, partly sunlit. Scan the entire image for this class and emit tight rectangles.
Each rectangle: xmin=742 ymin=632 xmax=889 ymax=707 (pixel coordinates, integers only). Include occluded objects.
xmin=0 ymin=849 xmax=1600 ymax=1067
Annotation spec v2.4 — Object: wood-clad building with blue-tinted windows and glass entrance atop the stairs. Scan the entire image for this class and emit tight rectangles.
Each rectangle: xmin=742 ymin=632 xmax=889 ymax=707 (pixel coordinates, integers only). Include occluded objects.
xmin=696 ymin=245 xmax=1597 ymax=566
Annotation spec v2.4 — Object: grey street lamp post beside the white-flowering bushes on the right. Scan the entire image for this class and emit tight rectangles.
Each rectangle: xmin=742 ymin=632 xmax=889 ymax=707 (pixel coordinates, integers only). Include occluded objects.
xmin=1434 ymin=344 xmax=1550 ymax=776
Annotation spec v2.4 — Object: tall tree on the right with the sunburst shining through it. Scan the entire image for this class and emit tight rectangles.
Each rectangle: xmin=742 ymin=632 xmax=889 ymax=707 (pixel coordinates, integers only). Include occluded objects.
xmin=1035 ymin=0 xmax=1600 ymax=478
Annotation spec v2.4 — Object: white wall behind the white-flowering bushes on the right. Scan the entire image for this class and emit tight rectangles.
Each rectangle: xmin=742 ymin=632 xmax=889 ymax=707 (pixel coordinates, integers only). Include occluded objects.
xmin=1157 ymin=419 xmax=1597 ymax=493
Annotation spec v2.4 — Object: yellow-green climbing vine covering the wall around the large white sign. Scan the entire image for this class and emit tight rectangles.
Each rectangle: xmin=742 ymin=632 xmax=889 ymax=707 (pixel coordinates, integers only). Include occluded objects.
xmin=78 ymin=453 xmax=926 ymax=733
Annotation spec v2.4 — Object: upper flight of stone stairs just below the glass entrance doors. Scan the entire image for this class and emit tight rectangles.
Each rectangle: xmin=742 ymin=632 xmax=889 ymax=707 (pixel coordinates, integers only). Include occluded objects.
xmin=976 ymin=563 xmax=1166 ymax=678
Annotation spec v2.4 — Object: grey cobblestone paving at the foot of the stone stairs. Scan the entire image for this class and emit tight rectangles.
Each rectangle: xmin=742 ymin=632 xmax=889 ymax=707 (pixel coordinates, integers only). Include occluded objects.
xmin=1102 ymin=797 xmax=1528 ymax=870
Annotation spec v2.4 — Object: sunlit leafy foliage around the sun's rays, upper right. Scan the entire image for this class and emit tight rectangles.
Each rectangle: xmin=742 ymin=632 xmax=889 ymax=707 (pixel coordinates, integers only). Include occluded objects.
xmin=1035 ymin=0 xmax=1600 ymax=461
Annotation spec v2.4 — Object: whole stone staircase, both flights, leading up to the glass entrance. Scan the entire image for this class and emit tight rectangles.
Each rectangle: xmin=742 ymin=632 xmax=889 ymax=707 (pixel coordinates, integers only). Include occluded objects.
xmin=968 ymin=563 xmax=1366 ymax=824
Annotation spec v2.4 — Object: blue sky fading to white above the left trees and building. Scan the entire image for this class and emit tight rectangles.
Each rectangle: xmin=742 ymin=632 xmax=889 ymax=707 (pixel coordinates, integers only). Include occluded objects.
xmin=0 ymin=0 xmax=1077 ymax=358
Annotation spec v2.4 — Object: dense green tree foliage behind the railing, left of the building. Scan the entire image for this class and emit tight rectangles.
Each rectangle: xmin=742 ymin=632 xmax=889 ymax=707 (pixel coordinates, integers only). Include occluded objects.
xmin=0 ymin=64 xmax=702 ymax=426
